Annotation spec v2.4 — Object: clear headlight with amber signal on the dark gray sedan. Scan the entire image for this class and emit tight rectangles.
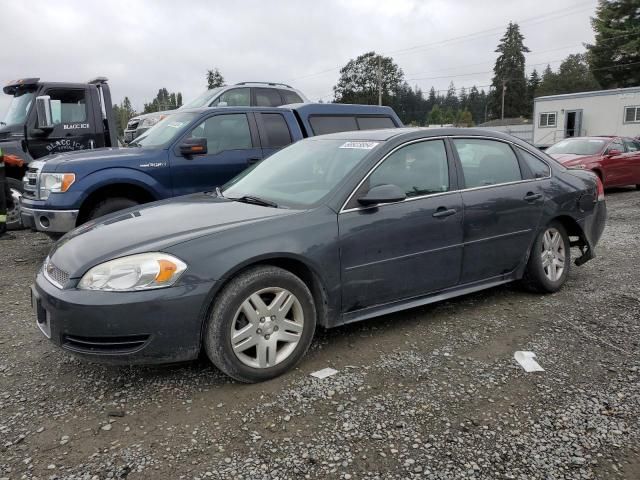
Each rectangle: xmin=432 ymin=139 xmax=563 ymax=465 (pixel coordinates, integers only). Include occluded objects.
xmin=78 ymin=252 xmax=187 ymax=292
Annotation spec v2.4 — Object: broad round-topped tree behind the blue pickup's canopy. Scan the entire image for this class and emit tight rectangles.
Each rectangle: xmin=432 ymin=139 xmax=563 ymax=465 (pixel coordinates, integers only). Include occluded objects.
xmin=333 ymin=52 xmax=404 ymax=105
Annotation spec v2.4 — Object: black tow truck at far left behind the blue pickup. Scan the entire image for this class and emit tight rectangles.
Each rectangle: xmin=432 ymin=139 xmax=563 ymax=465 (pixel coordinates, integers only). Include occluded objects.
xmin=0 ymin=77 xmax=118 ymax=229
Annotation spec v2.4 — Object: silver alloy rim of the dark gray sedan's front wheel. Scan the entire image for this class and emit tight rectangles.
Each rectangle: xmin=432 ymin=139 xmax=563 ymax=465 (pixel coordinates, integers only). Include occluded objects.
xmin=231 ymin=287 xmax=304 ymax=368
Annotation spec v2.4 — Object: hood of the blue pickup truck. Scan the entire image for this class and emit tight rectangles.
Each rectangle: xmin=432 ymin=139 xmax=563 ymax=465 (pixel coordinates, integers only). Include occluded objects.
xmin=43 ymin=147 xmax=162 ymax=172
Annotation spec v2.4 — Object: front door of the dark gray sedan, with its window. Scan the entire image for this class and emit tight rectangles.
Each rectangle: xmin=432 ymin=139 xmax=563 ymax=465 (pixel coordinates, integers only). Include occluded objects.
xmin=338 ymin=139 xmax=463 ymax=312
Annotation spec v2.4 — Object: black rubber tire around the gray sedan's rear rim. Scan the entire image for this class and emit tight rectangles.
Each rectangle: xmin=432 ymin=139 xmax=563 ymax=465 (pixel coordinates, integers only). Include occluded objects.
xmin=522 ymin=221 xmax=571 ymax=293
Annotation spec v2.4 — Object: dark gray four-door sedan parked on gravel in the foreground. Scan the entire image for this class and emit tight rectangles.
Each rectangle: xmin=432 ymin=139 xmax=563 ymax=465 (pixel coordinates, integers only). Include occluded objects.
xmin=32 ymin=129 xmax=606 ymax=382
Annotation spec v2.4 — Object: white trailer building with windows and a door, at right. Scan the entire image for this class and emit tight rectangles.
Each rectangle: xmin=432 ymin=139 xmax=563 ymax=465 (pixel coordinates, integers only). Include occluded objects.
xmin=533 ymin=87 xmax=640 ymax=147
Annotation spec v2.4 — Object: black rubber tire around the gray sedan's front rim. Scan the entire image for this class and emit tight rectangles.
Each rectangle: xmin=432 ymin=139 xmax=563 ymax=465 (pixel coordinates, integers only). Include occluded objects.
xmin=204 ymin=266 xmax=316 ymax=383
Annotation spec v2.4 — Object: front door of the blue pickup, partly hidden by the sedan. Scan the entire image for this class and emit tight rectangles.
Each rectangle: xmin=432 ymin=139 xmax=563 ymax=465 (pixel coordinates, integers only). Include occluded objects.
xmin=171 ymin=113 xmax=262 ymax=195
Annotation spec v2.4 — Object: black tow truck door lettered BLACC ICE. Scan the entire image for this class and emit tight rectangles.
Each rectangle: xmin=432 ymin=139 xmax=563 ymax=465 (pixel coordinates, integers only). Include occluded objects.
xmin=29 ymin=88 xmax=96 ymax=157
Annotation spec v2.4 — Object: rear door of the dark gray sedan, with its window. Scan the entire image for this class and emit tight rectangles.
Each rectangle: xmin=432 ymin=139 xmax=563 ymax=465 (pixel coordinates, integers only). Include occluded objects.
xmin=452 ymin=138 xmax=549 ymax=284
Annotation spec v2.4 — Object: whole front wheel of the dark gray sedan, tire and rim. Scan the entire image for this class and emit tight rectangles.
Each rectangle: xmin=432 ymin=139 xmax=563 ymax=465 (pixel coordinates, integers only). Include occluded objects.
xmin=204 ymin=266 xmax=316 ymax=383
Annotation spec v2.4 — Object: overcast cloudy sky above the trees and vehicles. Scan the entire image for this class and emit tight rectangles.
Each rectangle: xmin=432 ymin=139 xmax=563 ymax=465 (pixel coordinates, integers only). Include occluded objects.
xmin=0 ymin=0 xmax=597 ymax=117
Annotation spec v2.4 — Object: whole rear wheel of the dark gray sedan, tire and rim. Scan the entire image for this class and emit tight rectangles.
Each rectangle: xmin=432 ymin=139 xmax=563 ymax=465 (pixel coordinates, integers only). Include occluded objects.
xmin=523 ymin=221 xmax=571 ymax=293
